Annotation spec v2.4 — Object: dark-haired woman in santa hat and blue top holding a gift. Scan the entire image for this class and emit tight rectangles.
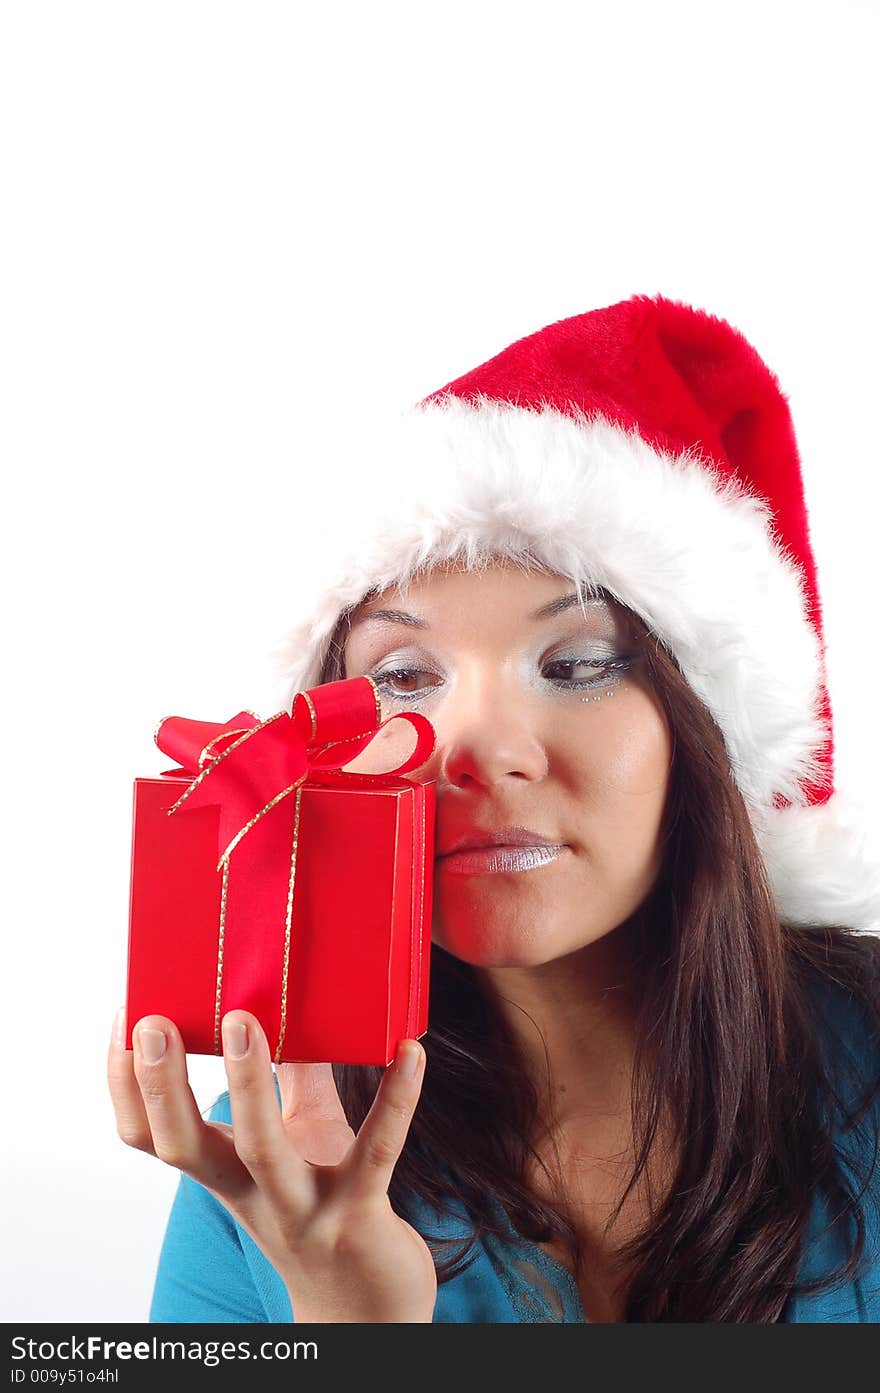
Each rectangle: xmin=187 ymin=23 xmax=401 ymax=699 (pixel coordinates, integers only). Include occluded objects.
xmin=109 ymin=297 xmax=880 ymax=1322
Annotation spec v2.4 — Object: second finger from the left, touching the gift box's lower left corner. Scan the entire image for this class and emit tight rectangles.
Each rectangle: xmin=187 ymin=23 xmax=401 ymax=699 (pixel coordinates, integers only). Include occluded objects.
xmin=132 ymin=1015 xmax=251 ymax=1198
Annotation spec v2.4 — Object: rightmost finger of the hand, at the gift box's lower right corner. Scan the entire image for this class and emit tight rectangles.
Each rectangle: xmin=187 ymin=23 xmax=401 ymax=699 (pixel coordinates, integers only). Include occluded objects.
xmin=344 ymin=1039 xmax=425 ymax=1199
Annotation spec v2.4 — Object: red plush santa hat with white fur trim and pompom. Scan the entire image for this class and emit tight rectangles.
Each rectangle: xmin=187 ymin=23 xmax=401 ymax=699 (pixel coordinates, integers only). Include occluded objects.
xmin=274 ymin=295 xmax=880 ymax=929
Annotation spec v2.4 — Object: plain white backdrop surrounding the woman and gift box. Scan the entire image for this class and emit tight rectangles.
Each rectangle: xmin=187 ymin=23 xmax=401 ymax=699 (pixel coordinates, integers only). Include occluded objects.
xmin=0 ymin=0 xmax=880 ymax=1322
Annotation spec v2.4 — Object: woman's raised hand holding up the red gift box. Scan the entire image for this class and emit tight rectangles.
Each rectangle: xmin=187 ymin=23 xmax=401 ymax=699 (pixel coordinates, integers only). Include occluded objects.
xmin=107 ymin=1011 xmax=437 ymax=1323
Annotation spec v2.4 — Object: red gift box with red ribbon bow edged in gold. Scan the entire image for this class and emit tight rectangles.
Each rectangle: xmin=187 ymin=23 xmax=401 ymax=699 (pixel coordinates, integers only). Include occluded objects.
xmin=125 ymin=677 xmax=434 ymax=1066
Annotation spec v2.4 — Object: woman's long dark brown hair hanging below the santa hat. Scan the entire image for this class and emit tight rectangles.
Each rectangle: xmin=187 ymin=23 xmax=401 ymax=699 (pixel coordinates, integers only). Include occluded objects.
xmin=322 ymin=576 xmax=880 ymax=1322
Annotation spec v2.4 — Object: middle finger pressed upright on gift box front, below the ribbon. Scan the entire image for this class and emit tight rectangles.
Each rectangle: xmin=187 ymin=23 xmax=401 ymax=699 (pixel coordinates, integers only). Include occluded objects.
xmin=221 ymin=1011 xmax=311 ymax=1206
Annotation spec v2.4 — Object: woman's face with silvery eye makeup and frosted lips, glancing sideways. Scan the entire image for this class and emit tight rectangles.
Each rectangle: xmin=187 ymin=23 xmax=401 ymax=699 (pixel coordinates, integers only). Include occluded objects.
xmin=345 ymin=563 xmax=673 ymax=967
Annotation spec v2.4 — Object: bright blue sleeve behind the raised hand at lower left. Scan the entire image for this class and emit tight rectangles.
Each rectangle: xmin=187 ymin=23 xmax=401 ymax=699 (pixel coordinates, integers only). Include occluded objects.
xmin=149 ymin=1095 xmax=292 ymax=1325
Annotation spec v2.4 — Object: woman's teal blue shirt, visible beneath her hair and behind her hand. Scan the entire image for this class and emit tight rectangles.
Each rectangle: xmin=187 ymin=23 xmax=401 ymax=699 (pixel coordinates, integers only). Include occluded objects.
xmin=150 ymin=999 xmax=880 ymax=1323
